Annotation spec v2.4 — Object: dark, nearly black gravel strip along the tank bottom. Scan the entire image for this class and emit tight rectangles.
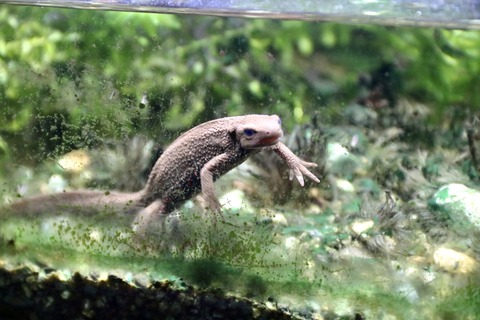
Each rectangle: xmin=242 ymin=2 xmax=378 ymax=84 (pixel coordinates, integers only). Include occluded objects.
xmin=0 ymin=266 xmax=303 ymax=319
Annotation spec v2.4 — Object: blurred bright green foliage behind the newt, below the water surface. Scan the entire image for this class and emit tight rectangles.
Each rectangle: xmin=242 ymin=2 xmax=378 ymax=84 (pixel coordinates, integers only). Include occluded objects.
xmin=0 ymin=6 xmax=480 ymax=164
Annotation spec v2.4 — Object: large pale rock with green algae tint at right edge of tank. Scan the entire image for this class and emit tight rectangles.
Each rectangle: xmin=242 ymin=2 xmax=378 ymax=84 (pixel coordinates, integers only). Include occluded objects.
xmin=429 ymin=183 xmax=480 ymax=230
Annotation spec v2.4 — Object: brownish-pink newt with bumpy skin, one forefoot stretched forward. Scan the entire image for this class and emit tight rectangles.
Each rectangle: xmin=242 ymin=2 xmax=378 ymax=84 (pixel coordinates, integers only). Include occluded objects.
xmin=5 ymin=115 xmax=319 ymax=233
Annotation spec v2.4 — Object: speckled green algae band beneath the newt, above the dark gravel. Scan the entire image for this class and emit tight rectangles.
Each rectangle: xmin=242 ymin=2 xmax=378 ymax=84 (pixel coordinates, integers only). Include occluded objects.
xmin=0 ymin=209 xmax=424 ymax=318
